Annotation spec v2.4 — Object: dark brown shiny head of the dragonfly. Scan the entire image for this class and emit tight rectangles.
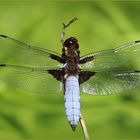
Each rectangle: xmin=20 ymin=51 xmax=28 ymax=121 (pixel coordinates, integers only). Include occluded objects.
xmin=64 ymin=37 xmax=79 ymax=50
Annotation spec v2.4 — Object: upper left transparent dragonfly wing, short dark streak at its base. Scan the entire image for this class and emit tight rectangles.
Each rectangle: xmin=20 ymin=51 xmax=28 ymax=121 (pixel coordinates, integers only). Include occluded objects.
xmin=0 ymin=35 xmax=61 ymax=68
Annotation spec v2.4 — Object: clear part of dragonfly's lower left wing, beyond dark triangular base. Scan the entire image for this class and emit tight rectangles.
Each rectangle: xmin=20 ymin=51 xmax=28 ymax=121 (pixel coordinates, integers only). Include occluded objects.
xmin=0 ymin=64 xmax=63 ymax=93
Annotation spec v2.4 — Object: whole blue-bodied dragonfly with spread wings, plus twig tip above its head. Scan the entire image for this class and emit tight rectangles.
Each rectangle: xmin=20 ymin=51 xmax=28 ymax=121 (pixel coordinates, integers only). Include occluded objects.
xmin=0 ymin=18 xmax=140 ymax=130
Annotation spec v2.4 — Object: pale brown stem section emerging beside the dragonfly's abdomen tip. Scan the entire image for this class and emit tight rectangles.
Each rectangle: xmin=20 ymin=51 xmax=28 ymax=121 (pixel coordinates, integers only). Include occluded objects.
xmin=80 ymin=114 xmax=89 ymax=140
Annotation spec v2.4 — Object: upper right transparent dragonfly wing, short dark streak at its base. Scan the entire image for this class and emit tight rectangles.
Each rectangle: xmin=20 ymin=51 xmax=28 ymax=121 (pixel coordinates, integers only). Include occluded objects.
xmin=80 ymin=41 xmax=140 ymax=71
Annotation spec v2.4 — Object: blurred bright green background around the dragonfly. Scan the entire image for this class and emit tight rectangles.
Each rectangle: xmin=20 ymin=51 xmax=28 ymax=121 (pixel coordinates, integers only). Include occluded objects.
xmin=0 ymin=0 xmax=140 ymax=140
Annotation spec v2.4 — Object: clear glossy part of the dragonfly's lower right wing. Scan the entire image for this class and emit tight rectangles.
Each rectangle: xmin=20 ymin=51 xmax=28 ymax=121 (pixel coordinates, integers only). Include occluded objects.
xmin=80 ymin=71 xmax=140 ymax=95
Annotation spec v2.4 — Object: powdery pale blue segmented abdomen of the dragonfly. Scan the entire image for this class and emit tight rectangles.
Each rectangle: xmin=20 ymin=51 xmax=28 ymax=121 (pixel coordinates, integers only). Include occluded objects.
xmin=64 ymin=76 xmax=80 ymax=130
